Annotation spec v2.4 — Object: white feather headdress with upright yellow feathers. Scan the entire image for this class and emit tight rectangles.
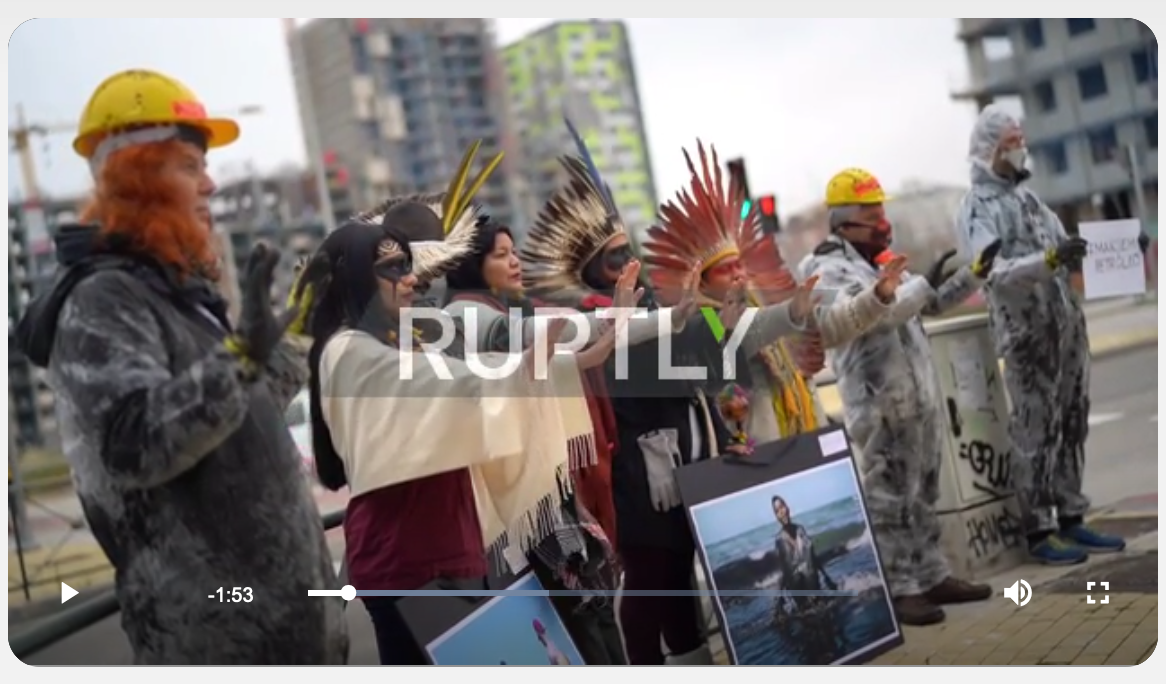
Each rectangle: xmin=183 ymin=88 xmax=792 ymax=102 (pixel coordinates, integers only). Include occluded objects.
xmin=352 ymin=140 xmax=503 ymax=281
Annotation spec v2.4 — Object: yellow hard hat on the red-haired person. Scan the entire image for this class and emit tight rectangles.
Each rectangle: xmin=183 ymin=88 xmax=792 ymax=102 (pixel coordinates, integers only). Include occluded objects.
xmin=73 ymin=69 xmax=239 ymax=158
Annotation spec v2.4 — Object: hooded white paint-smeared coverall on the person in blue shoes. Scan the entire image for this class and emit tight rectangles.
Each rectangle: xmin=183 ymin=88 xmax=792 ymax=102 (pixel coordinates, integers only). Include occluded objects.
xmin=958 ymin=110 xmax=1089 ymax=534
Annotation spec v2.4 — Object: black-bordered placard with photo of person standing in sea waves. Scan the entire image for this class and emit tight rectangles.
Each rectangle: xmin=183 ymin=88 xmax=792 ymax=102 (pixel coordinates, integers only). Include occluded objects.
xmin=676 ymin=426 xmax=902 ymax=665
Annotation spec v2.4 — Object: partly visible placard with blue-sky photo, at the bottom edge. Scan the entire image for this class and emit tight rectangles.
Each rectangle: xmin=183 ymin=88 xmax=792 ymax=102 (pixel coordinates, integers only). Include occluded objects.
xmin=398 ymin=572 xmax=585 ymax=665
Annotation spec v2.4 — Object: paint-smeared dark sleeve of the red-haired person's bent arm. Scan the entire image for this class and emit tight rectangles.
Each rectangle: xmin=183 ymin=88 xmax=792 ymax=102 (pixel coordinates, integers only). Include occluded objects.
xmin=51 ymin=270 xmax=250 ymax=489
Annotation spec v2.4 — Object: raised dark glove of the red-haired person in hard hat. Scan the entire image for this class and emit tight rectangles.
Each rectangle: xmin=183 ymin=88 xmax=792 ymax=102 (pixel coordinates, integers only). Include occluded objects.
xmin=225 ymin=242 xmax=298 ymax=374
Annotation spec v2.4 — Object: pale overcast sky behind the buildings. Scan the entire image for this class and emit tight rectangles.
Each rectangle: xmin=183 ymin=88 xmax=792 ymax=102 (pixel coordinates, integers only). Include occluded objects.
xmin=8 ymin=19 xmax=1012 ymax=213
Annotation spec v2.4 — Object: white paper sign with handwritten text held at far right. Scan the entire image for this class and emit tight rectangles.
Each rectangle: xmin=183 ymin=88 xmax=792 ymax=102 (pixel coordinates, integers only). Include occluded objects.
xmin=1079 ymin=219 xmax=1146 ymax=299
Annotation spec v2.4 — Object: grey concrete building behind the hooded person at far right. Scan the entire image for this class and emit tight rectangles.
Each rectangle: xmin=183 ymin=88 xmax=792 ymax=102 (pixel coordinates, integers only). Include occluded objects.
xmin=954 ymin=19 xmax=1158 ymax=233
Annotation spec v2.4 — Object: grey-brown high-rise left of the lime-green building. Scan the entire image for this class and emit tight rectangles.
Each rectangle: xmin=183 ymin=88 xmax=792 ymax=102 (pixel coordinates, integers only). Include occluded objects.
xmin=293 ymin=19 xmax=513 ymax=221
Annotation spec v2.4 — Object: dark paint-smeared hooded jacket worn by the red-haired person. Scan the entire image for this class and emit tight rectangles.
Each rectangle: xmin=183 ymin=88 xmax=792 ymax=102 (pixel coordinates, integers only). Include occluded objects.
xmin=26 ymin=256 xmax=347 ymax=665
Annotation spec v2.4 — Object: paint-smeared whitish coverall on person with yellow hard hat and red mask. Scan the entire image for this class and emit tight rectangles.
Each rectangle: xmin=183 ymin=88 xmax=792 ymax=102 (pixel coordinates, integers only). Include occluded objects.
xmin=801 ymin=235 xmax=982 ymax=597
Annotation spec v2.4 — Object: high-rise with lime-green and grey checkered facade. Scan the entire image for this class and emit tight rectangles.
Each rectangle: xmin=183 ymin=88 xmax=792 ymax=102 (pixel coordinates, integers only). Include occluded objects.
xmin=503 ymin=20 xmax=656 ymax=241
